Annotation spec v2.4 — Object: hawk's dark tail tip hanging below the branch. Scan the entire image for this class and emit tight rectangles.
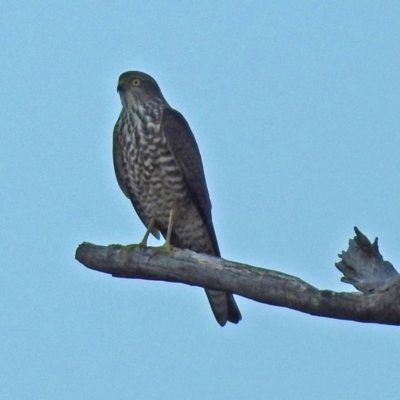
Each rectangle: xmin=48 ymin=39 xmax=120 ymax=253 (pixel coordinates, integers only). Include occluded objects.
xmin=205 ymin=289 xmax=242 ymax=326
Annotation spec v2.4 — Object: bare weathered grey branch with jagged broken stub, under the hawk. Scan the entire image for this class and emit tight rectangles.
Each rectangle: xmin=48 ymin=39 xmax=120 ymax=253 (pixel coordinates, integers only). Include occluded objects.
xmin=76 ymin=228 xmax=400 ymax=325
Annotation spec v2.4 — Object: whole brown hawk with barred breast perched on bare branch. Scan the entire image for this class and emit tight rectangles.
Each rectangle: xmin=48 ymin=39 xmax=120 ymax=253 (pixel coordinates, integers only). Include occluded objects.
xmin=113 ymin=71 xmax=241 ymax=326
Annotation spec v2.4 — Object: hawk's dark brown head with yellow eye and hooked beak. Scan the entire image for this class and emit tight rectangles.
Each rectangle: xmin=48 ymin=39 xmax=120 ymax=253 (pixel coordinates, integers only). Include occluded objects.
xmin=117 ymin=71 xmax=163 ymax=107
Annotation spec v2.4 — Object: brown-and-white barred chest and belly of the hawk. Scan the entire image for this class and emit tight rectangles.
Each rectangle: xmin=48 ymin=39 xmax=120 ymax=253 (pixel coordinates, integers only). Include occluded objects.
xmin=115 ymin=106 xmax=187 ymax=226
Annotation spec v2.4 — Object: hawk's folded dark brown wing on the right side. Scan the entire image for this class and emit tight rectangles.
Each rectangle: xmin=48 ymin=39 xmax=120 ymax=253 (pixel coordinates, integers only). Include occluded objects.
xmin=161 ymin=108 xmax=220 ymax=256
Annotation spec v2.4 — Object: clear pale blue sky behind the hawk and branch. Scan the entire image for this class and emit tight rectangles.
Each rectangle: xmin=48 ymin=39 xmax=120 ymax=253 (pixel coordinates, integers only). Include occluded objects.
xmin=0 ymin=0 xmax=400 ymax=400
